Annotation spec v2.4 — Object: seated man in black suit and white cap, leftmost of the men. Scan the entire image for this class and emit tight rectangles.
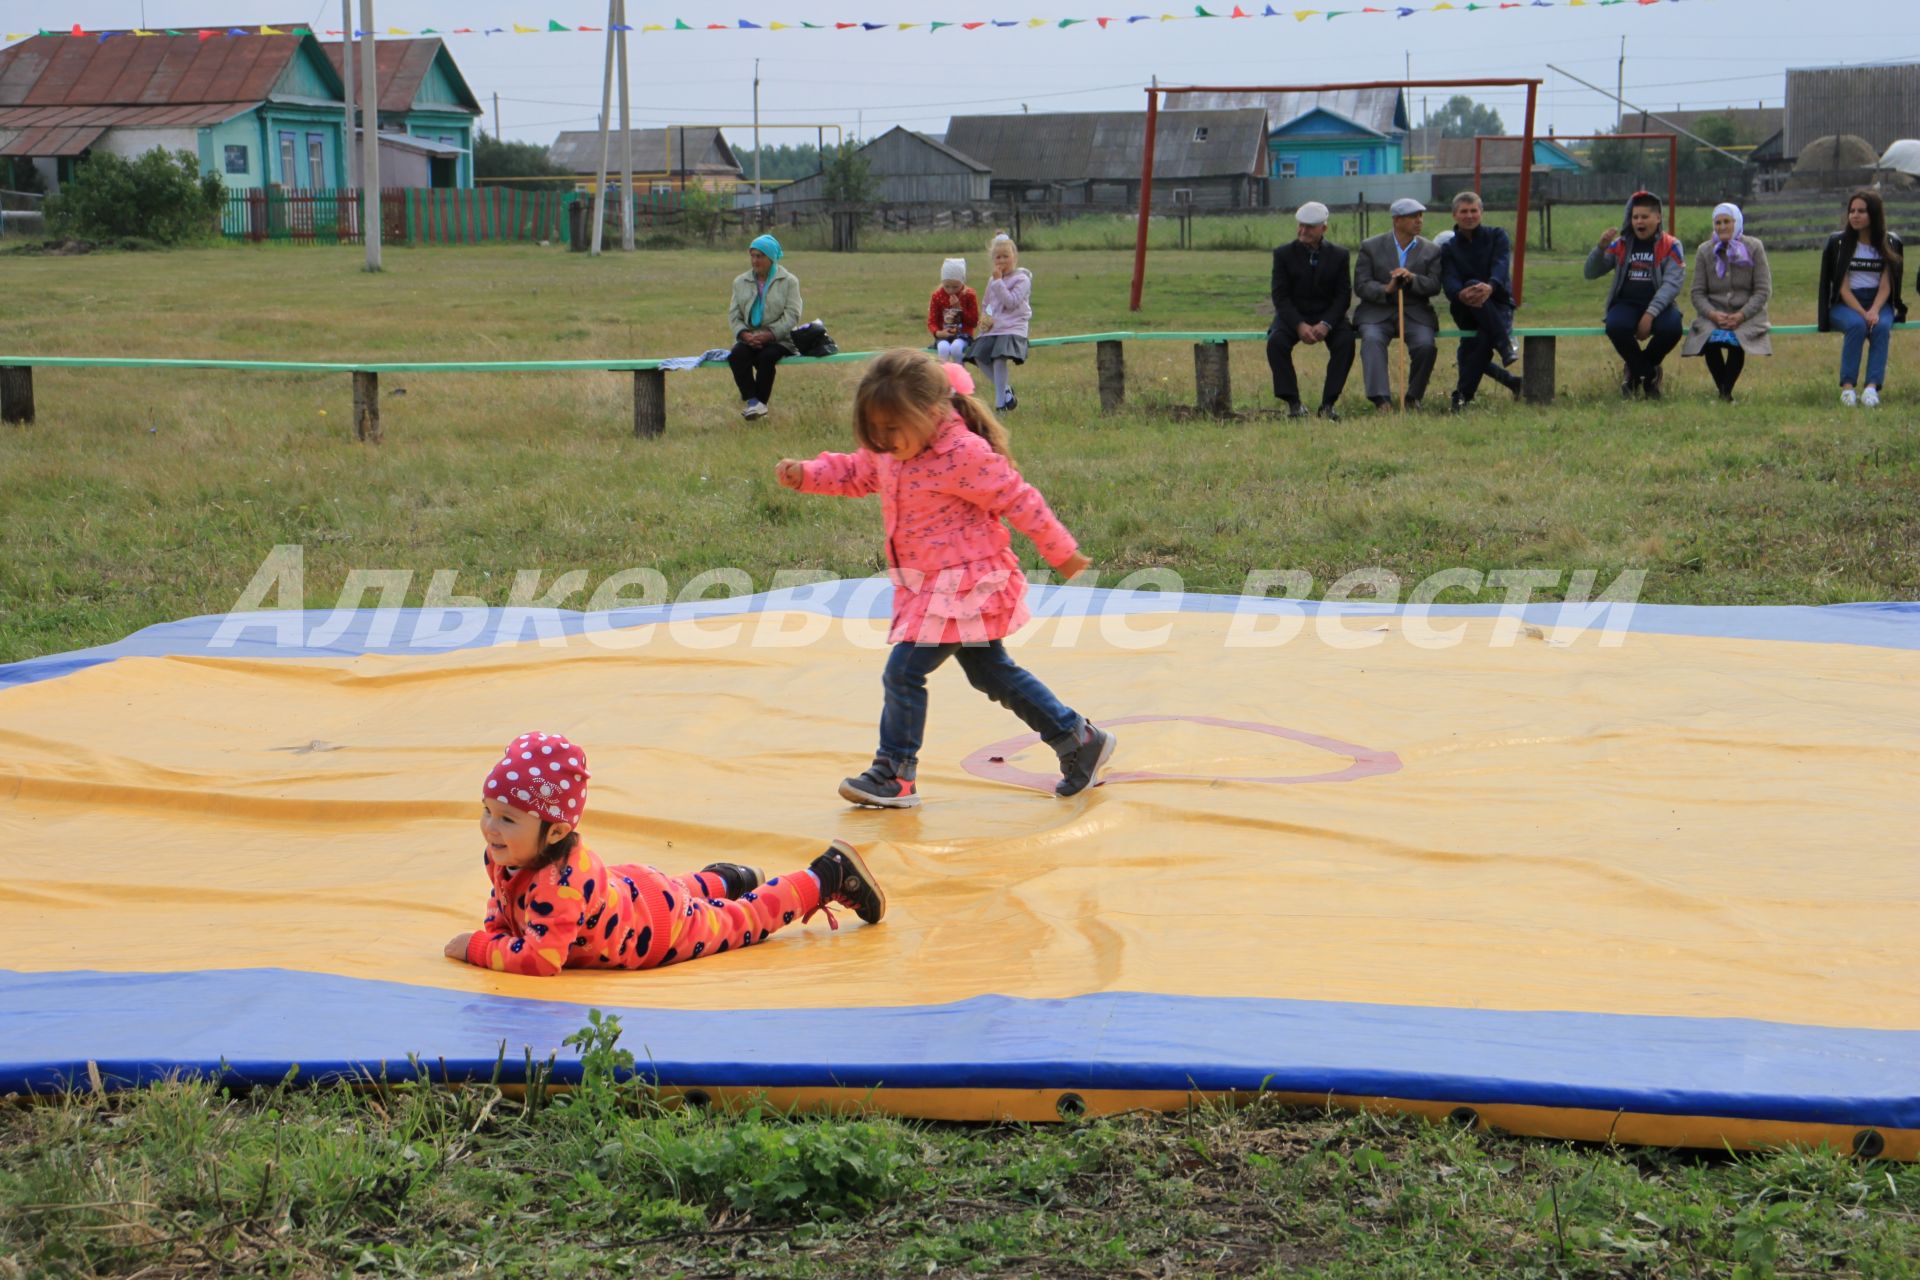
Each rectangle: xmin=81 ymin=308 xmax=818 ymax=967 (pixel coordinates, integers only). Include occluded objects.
xmin=1267 ymin=200 xmax=1354 ymax=422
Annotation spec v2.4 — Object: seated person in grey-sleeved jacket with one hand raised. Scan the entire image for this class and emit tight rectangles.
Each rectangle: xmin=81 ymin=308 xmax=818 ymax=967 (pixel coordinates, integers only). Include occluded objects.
xmin=1586 ymin=192 xmax=1686 ymax=399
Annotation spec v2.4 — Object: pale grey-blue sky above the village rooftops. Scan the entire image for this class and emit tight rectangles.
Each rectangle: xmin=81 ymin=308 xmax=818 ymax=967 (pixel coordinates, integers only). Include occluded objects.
xmin=15 ymin=0 xmax=1920 ymax=146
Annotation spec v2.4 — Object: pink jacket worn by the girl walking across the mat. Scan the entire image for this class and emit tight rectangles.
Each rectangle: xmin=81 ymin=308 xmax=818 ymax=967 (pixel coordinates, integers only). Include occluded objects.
xmin=801 ymin=413 xmax=1079 ymax=645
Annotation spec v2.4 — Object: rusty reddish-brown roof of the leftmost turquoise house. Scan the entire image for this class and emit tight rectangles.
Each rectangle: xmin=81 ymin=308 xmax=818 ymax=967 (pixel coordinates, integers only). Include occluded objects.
xmin=0 ymin=23 xmax=334 ymax=107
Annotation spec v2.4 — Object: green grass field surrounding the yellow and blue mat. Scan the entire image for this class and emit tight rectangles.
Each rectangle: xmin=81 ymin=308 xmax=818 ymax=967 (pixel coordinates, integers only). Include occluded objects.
xmin=0 ymin=235 xmax=1920 ymax=1280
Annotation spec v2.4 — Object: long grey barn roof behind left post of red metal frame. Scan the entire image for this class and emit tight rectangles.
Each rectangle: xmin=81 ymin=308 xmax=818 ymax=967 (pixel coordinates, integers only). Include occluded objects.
xmin=947 ymin=107 xmax=1267 ymax=182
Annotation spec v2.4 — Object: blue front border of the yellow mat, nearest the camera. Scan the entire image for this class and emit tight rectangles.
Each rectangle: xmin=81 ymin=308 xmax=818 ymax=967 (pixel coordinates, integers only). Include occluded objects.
xmin=0 ymin=974 xmax=1920 ymax=1128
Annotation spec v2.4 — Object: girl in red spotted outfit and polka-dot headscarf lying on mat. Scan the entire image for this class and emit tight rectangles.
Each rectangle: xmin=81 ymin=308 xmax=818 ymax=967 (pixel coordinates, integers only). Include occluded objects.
xmin=445 ymin=733 xmax=887 ymax=977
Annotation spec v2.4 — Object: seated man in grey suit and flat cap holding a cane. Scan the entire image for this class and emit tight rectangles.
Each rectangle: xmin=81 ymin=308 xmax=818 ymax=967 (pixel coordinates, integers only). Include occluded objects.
xmin=1354 ymin=198 xmax=1440 ymax=409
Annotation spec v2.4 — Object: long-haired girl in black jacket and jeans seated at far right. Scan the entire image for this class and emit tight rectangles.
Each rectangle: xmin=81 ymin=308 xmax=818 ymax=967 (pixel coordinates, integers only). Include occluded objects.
xmin=1820 ymin=190 xmax=1907 ymax=409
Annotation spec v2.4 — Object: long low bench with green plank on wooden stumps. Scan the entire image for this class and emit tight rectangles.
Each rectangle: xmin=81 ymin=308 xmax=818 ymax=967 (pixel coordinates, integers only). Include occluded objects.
xmin=0 ymin=322 xmax=1866 ymax=443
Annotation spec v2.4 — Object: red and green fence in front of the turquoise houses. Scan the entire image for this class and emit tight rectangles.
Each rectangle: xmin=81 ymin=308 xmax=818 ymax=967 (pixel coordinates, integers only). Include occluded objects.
xmin=221 ymin=186 xmax=576 ymax=244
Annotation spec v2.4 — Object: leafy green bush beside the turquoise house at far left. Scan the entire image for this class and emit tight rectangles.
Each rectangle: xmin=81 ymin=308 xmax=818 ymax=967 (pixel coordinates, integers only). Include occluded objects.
xmin=46 ymin=148 xmax=227 ymax=244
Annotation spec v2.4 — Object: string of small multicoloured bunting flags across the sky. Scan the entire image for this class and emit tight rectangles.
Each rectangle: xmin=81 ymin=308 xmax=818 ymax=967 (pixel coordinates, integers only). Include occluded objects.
xmin=0 ymin=0 xmax=1703 ymax=44
